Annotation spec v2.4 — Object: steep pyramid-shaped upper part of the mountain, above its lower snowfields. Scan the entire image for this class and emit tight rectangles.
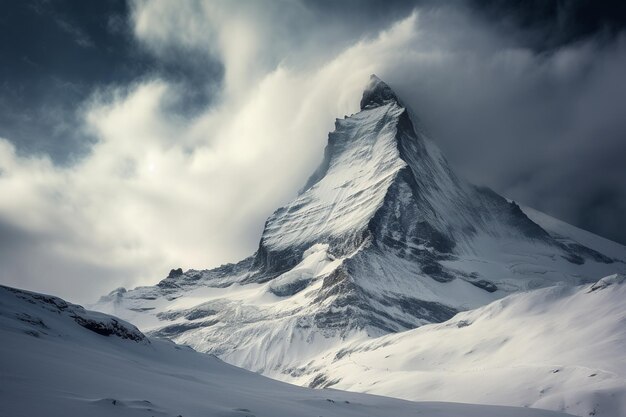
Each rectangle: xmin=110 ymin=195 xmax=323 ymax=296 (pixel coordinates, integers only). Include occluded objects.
xmin=254 ymin=75 xmax=592 ymax=287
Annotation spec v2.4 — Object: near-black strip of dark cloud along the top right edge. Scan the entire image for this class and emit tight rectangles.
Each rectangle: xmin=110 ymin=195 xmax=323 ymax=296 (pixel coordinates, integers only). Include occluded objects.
xmin=304 ymin=0 xmax=626 ymax=51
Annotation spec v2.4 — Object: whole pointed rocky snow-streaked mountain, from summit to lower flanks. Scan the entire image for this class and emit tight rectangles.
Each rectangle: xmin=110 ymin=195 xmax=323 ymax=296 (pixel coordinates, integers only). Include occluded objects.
xmin=96 ymin=76 xmax=626 ymax=378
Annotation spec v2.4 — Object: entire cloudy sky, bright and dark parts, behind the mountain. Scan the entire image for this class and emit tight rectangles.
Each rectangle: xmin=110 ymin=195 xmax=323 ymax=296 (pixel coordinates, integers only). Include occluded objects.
xmin=0 ymin=0 xmax=626 ymax=303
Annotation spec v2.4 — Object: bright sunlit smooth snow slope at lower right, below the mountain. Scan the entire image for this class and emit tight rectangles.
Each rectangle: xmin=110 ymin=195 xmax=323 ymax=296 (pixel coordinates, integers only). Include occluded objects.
xmin=295 ymin=275 xmax=626 ymax=417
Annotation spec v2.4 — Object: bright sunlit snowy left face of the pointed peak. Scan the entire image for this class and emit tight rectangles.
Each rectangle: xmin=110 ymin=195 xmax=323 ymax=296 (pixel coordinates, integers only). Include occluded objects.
xmin=259 ymin=92 xmax=406 ymax=272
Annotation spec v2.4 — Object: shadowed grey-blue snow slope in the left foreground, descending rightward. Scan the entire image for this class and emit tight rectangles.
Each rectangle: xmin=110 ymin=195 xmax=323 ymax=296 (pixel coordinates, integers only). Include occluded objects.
xmin=0 ymin=287 xmax=564 ymax=417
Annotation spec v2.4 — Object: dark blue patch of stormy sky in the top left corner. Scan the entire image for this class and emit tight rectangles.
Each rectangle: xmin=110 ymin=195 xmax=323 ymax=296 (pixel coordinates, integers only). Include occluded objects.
xmin=0 ymin=0 xmax=222 ymax=163
